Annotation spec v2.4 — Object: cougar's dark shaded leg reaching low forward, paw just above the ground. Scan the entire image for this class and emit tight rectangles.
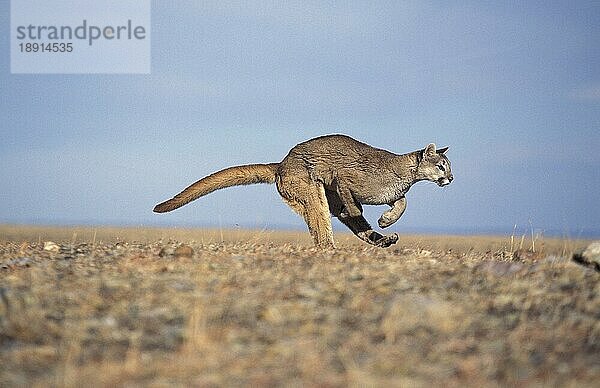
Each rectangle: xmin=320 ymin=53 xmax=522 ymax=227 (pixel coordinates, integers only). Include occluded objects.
xmin=325 ymin=190 xmax=398 ymax=248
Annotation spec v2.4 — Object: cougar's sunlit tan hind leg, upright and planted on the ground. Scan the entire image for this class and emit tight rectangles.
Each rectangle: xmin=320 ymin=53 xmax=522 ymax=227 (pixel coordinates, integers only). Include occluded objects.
xmin=276 ymin=178 xmax=335 ymax=248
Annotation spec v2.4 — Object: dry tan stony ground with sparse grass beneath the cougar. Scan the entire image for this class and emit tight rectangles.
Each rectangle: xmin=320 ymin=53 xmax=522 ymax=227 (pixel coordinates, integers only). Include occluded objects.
xmin=0 ymin=226 xmax=600 ymax=387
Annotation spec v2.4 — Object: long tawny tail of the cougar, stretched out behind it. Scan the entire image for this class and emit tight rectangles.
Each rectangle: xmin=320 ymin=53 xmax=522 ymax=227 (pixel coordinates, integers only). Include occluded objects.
xmin=154 ymin=163 xmax=279 ymax=213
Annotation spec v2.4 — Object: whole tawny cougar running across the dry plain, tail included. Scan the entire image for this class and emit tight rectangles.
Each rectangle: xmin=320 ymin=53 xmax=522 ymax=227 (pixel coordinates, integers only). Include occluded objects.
xmin=154 ymin=135 xmax=454 ymax=248
